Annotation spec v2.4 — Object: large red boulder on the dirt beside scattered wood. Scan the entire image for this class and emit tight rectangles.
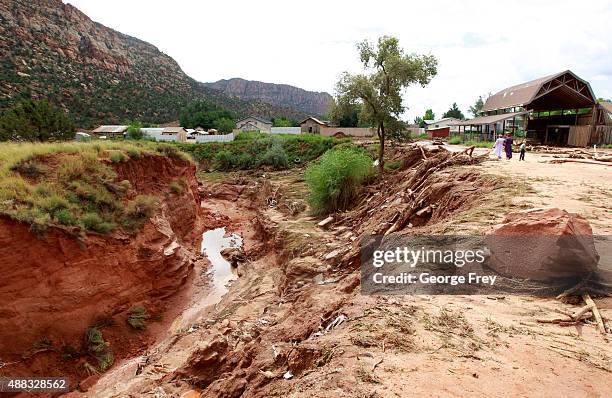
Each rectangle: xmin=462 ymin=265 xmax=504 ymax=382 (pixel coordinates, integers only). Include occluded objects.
xmin=486 ymin=208 xmax=599 ymax=280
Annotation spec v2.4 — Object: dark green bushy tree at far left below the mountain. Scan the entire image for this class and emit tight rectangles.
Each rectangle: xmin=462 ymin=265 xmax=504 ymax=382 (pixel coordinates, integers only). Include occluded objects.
xmin=0 ymin=100 xmax=75 ymax=141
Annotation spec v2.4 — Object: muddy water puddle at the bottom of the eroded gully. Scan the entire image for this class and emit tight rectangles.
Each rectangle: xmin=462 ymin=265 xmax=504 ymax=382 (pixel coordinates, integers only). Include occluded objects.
xmin=173 ymin=227 xmax=243 ymax=330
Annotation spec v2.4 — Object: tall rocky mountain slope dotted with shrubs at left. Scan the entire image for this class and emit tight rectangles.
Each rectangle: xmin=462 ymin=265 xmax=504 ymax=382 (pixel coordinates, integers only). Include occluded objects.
xmin=0 ymin=0 xmax=305 ymax=127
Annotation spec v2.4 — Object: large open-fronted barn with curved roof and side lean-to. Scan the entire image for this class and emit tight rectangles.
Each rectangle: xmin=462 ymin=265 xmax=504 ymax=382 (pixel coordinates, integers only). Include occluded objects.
xmin=456 ymin=70 xmax=612 ymax=146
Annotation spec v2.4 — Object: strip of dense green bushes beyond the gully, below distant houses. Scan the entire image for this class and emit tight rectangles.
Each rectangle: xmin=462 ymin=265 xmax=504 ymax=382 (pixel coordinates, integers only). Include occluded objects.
xmin=176 ymin=133 xmax=350 ymax=171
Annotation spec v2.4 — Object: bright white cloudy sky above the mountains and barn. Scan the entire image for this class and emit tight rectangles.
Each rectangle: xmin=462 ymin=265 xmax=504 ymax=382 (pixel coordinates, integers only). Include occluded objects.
xmin=64 ymin=0 xmax=612 ymax=120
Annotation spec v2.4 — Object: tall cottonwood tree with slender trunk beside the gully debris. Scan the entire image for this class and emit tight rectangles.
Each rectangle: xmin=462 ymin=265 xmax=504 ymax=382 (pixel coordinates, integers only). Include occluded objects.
xmin=336 ymin=36 xmax=438 ymax=174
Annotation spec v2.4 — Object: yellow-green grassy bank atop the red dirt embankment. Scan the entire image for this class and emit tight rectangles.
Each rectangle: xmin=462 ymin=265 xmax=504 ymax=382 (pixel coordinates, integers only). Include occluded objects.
xmin=0 ymin=141 xmax=187 ymax=234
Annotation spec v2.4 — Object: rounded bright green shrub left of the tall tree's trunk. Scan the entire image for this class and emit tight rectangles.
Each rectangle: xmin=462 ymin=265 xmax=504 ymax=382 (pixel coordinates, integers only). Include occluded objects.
xmin=305 ymin=148 xmax=374 ymax=215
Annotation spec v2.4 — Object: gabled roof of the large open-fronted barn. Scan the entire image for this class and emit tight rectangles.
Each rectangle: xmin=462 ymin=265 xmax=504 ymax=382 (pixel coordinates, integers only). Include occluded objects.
xmin=482 ymin=70 xmax=595 ymax=112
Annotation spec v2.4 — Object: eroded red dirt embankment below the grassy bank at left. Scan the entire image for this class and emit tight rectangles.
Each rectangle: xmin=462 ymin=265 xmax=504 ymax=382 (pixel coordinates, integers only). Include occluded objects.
xmin=0 ymin=155 xmax=215 ymax=377
